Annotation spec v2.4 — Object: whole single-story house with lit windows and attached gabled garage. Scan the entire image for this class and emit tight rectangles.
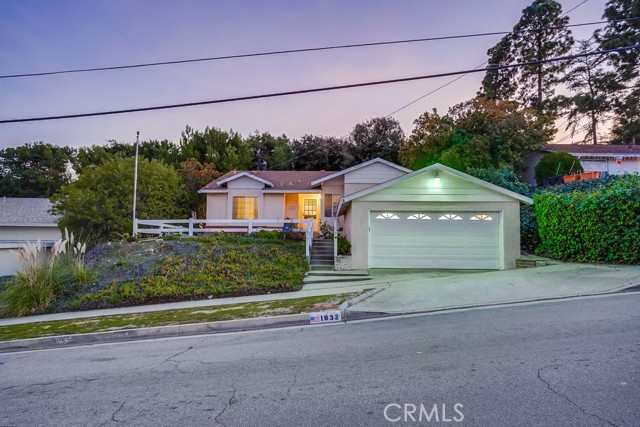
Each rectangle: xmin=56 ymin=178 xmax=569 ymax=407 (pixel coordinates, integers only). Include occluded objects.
xmin=200 ymin=159 xmax=532 ymax=269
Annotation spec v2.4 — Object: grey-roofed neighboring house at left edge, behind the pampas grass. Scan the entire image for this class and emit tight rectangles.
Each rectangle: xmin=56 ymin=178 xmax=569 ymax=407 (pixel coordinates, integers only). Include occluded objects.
xmin=0 ymin=197 xmax=61 ymax=276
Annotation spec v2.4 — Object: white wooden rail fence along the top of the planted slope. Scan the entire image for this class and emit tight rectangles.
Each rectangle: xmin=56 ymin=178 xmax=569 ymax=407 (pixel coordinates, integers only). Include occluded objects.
xmin=133 ymin=218 xmax=313 ymax=262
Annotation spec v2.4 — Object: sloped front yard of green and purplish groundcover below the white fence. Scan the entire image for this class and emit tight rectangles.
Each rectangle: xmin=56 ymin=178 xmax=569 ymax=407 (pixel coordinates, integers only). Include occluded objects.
xmin=60 ymin=234 xmax=307 ymax=312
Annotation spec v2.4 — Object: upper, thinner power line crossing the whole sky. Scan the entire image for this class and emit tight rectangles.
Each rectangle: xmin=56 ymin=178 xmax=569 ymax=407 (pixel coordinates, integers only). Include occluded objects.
xmin=0 ymin=17 xmax=640 ymax=79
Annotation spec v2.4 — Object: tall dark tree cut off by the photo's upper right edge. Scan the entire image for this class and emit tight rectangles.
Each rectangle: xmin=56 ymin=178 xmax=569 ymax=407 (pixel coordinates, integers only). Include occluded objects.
xmin=596 ymin=0 xmax=640 ymax=143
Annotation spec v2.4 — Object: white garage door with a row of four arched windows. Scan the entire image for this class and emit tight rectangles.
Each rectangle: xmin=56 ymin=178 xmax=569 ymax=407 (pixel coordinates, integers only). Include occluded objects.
xmin=369 ymin=211 xmax=500 ymax=269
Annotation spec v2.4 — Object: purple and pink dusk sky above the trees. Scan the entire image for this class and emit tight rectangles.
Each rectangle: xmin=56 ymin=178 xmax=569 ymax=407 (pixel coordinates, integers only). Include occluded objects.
xmin=0 ymin=0 xmax=605 ymax=148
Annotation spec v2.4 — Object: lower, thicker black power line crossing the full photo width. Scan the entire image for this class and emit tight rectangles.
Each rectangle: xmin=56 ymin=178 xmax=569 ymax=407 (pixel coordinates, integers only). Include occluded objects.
xmin=0 ymin=44 xmax=640 ymax=124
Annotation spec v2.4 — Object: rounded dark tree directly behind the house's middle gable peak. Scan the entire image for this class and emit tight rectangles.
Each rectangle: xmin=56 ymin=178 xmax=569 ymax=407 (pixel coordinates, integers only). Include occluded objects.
xmin=347 ymin=117 xmax=405 ymax=164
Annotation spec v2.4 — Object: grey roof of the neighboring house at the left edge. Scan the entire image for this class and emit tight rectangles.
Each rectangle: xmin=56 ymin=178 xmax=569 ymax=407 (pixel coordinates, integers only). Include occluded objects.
xmin=0 ymin=197 xmax=58 ymax=227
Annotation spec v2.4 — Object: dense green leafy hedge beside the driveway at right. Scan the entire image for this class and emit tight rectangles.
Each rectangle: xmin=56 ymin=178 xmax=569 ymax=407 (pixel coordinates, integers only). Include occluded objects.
xmin=534 ymin=175 xmax=640 ymax=264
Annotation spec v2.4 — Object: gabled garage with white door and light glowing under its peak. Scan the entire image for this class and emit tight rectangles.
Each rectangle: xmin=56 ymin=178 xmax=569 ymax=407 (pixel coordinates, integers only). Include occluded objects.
xmin=338 ymin=164 xmax=533 ymax=270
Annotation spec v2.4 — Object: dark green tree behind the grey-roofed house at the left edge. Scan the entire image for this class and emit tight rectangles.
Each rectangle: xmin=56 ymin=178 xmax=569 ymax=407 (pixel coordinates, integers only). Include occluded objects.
xmin=0 ymin=141 xmax=73 ymax=197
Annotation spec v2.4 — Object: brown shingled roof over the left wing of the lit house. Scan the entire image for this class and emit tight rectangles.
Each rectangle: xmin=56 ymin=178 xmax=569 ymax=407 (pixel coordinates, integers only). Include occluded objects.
xmin=198 ymin=171 xmax=335 ymax=193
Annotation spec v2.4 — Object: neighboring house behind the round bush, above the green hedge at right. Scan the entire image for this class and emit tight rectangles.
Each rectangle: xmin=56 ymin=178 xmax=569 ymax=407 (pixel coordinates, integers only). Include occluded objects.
xmin=522 ymin=144 xmax=640 ymax=185
